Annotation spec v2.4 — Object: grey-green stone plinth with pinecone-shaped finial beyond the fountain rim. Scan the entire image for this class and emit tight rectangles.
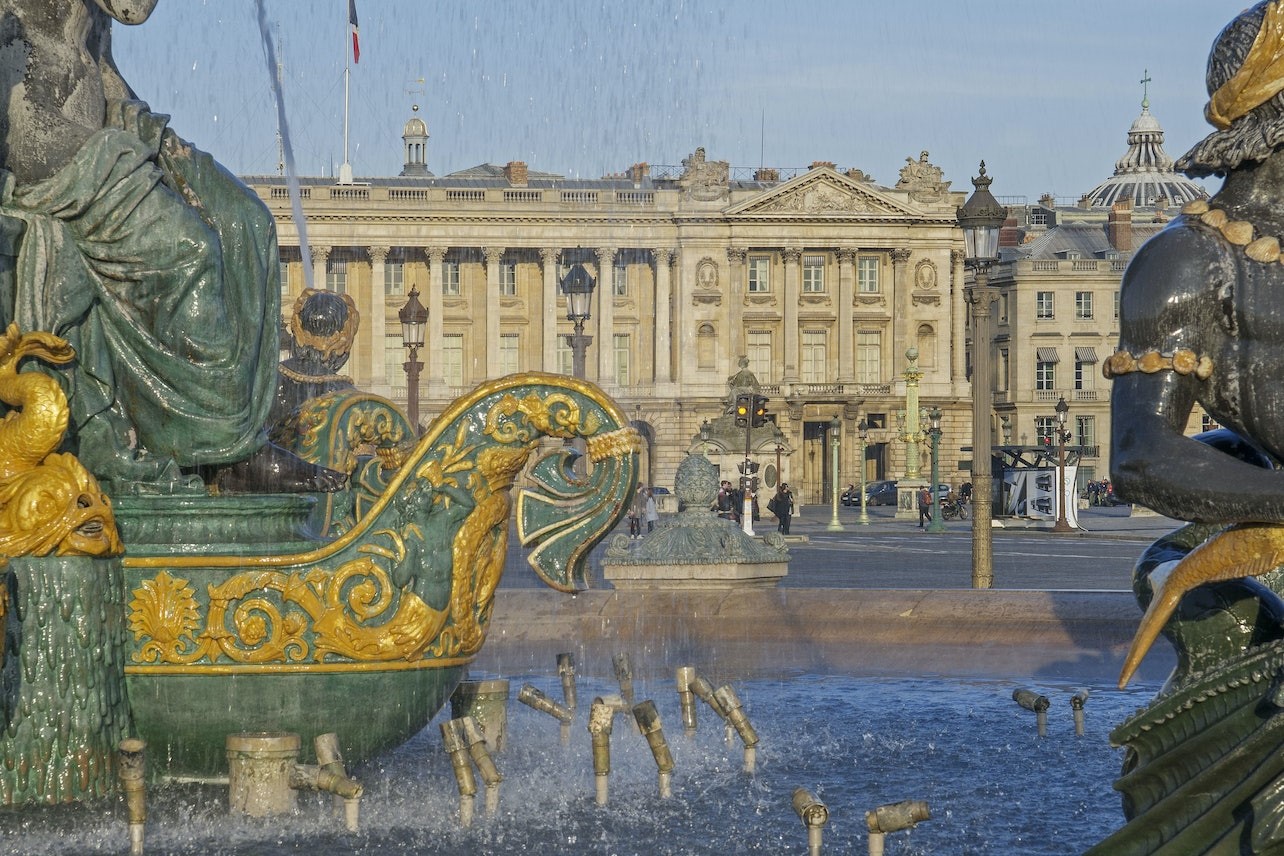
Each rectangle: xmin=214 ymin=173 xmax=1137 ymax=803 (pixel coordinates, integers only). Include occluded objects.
xmin=602 ymin=454 xmax=790 ymax=589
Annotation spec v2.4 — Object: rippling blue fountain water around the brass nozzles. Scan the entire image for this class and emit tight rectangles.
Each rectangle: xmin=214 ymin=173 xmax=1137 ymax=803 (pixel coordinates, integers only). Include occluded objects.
xmin=0 ymin=665 xmax=1157 ymax=856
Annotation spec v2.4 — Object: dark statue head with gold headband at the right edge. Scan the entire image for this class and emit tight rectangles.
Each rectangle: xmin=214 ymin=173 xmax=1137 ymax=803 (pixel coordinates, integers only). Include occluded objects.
xmin=1176 ymin=0 xmax=1284 ymax=177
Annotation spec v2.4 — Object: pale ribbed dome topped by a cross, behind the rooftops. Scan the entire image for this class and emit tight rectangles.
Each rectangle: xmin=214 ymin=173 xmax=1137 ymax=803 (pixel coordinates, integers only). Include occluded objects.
xmin=1084 ymin=99 xmax=1208 ymax=208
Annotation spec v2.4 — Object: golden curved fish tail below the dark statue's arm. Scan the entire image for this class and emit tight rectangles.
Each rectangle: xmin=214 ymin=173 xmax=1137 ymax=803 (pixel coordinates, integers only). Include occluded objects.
xmin=1118 ymin=524 xmax=1284 ymax=689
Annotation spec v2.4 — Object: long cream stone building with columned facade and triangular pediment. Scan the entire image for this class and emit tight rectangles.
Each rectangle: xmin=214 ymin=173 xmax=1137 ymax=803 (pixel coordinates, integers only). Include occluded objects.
xmin=244 ymin=131 xmax=971 ymax=502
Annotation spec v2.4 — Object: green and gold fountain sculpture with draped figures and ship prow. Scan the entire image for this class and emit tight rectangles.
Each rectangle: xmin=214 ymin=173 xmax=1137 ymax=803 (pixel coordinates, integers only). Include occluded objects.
xmin=0 ymin=0 xmax=641 ymax=805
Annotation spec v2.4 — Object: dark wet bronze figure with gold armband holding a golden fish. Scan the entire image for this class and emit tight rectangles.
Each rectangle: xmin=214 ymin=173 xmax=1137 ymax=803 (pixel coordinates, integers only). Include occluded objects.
xmin=1091 ymin=0 xmax=1284 ymax=856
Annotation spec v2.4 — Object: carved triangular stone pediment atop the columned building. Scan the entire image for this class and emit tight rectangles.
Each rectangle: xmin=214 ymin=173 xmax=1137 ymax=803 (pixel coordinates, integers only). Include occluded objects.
xmin=727 ymin=167 xmax=922 ymax=218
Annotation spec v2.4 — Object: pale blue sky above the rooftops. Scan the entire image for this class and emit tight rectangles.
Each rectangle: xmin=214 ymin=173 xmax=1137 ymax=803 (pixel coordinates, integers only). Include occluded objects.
xmin=113 ymin=0 xmax=1247 ymax=200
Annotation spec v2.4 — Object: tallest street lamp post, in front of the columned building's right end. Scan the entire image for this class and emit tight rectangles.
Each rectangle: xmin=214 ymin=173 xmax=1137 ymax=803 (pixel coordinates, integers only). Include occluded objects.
xmin=957 ymin=160 xmax=1008 ymax=589
